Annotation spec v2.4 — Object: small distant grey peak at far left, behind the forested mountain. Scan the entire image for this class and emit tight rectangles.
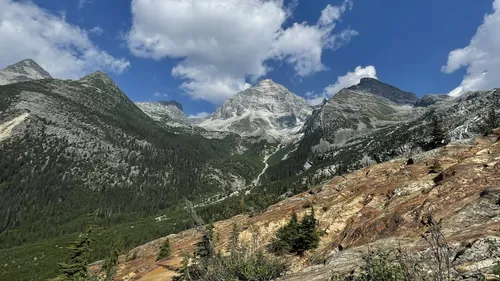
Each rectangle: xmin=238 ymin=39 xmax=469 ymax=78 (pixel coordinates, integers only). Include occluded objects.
xmin=0 ymin=59 xmax=52 ymax=85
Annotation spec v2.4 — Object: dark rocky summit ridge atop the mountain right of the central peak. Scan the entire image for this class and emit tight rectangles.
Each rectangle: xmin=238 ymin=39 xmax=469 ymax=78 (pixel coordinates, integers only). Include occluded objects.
xmin=347 ymin=78 xmax=418 ymax=105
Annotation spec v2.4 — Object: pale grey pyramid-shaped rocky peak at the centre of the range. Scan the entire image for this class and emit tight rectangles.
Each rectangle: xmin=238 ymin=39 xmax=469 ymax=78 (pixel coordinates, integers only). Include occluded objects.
xmin=198 ymin=79 xmax=312 ymax=138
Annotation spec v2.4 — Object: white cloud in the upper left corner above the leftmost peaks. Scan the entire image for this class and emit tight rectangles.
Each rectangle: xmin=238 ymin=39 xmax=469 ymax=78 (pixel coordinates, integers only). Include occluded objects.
xmin=0 ymin=0 xmax=130 ymax=79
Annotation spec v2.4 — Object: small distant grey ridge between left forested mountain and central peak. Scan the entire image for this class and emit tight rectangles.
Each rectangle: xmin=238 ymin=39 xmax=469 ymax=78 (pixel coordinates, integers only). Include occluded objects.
xmin=135 ymin=101 xmax=188 ymax=123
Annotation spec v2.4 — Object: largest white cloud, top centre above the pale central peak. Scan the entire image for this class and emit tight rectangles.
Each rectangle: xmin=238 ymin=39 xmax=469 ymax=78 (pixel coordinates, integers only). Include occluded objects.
xmin=126 ymin=0 xmax=357 ymax=103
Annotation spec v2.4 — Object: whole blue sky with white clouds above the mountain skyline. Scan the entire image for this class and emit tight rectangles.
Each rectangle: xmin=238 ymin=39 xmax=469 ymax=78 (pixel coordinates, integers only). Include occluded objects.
xmin=0 ymin=0 xmax=500 ymax=116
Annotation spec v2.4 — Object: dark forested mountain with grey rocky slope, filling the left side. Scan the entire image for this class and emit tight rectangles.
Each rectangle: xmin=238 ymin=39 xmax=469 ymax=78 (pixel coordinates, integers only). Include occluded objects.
xmin=0 ymin=63 xmax=263 ymax=256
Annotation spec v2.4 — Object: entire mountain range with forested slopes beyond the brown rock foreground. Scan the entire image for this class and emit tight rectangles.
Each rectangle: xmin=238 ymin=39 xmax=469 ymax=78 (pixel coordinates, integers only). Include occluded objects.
xmin=0 ymin=60 xmax=500 ymax=280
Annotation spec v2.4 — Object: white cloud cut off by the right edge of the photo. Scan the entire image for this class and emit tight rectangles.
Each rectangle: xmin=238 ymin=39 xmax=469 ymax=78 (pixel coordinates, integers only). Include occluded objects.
xmin=442 ymin=0 xmax=500 ymax=96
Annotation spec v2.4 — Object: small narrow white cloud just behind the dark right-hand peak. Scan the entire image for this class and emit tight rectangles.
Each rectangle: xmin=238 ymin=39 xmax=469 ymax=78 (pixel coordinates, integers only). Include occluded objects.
xmin=306 ymin=65 xmax=377 ymax=105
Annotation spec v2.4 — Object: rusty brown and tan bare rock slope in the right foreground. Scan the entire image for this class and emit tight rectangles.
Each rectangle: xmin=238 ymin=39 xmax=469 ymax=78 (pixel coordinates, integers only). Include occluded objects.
xmin=102 ymin=130 xmax=500 ymax=281
